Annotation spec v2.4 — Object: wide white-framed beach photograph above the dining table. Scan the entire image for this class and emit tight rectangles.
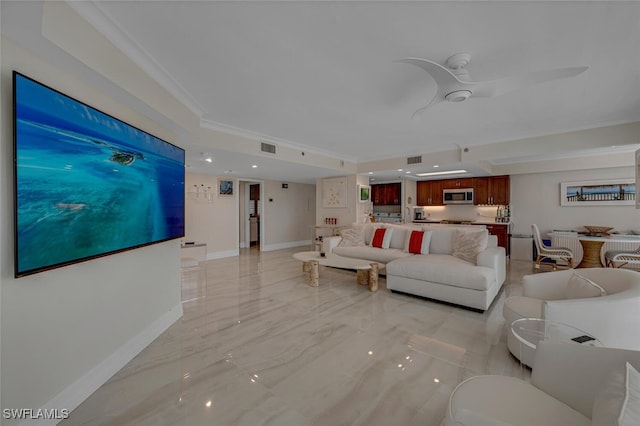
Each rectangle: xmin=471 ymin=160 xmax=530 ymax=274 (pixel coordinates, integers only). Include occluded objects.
xmin=560 ymin=178 xmax=637 ymax=206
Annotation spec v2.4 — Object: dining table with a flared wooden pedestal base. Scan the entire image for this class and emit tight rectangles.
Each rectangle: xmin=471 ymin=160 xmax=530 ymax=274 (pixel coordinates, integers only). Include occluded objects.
xmin=547 ymin=232 xmax=640 ymax=268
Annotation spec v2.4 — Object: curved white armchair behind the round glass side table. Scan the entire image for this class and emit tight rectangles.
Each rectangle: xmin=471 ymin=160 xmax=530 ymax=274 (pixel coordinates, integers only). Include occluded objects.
xmin=503 ymin=268 xmax=640 ymax=365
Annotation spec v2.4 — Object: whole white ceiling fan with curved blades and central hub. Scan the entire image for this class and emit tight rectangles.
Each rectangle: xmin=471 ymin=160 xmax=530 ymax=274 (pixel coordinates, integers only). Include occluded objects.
xmin=394 ymin=53 xmax=589 ymax=118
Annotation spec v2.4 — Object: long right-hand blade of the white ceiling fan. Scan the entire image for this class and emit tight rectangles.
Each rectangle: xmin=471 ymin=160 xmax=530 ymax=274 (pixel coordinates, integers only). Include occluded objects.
xmin=469 ymin=67 xmax=589 ymax=98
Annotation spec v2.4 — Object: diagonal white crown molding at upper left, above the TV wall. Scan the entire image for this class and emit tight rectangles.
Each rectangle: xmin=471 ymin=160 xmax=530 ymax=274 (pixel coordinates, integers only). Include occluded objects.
xmin=66 ymin=0 xmax=206 ymax=117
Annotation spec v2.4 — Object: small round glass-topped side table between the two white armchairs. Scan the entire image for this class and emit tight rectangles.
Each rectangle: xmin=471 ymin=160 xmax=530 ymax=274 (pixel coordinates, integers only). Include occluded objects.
xmin=511 ymin=318 xmax=604 ymax=366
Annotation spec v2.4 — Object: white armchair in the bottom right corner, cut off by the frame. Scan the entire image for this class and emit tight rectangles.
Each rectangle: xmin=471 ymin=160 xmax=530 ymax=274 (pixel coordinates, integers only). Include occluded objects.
xmin=443 ymin=341 xmax=640 ymax=426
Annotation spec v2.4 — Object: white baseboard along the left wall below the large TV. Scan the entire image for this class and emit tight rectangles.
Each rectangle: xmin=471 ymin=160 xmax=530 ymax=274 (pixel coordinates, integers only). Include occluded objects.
xmin=24 ymin=303 xmax=182 ymax=426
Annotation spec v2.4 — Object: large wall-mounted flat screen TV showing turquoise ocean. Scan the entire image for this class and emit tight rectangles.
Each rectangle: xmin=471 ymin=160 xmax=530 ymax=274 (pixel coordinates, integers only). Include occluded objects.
xmin=13 ymin=71 xmax=185 ymax=277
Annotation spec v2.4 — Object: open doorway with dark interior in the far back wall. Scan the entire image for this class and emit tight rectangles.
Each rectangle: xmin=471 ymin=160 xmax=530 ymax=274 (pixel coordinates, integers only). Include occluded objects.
xmin=239 ymin=181 xmax=264 ymax=251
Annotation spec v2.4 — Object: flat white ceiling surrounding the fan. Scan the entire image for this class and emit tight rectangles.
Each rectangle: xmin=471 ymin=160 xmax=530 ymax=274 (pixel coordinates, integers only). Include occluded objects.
xmin=3 ymin=1 xmax=640 ymax=185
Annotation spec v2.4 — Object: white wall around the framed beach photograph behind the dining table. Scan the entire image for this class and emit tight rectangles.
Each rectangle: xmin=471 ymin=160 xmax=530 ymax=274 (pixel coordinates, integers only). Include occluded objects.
xmin=511 ymin=166 xmax=640 ymax=233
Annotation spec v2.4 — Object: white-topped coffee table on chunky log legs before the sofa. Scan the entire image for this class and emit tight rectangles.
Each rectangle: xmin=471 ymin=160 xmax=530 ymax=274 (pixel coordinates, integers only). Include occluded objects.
xmin=293 ymin=251 xmax=384 ymax=291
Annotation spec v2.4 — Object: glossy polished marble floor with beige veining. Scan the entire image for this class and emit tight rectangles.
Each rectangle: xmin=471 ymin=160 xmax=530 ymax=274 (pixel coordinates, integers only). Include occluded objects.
xmin=60 ymin=249 xmax=532 ymax=426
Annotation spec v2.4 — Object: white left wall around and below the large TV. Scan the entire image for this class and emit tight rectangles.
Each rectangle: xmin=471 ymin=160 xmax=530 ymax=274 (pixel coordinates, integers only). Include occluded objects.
xmin=0 ymin=5 xmax=190 ymax=424
